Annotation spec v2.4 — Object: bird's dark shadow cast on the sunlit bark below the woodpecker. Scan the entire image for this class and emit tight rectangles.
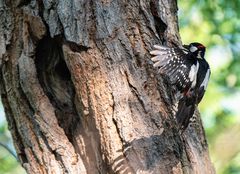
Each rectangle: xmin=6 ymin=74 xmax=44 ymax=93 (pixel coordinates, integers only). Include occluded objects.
xmin=112 ymin=131 xmax=184 ymax=173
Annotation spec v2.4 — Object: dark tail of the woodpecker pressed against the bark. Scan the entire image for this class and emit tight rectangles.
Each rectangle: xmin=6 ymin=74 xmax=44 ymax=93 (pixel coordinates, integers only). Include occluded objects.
xmin=176 ymin=97 xmax=196 ymax=130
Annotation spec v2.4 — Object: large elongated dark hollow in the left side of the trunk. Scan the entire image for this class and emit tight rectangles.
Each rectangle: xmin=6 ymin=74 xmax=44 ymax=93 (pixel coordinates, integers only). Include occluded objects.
xmin=35 ymin=36 xmax=80 ymax=141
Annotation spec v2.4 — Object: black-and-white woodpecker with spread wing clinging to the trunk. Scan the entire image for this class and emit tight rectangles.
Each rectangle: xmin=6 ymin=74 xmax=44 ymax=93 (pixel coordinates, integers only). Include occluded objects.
xmin=150 ymin=42 xmax=211 ymax=130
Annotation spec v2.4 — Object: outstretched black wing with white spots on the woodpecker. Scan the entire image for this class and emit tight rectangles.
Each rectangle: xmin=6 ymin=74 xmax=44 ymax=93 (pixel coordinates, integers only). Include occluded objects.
xmin=150 ymin=45 xmax=193 ymax=90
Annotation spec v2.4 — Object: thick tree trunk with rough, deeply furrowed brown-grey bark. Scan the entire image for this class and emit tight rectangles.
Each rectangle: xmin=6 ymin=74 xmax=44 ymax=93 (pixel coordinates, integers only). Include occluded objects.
xmin=0 ymin=0 xmax=214 ymax=174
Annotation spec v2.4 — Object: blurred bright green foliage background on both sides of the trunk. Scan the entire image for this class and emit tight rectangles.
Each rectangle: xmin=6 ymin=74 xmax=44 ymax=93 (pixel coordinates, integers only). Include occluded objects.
xmin=0 ymin=0 xmax=240 ymax=174
